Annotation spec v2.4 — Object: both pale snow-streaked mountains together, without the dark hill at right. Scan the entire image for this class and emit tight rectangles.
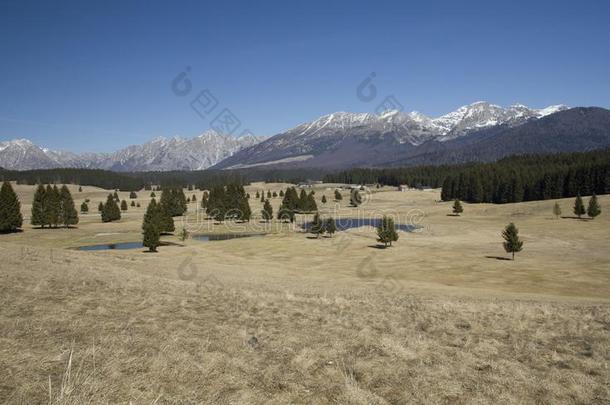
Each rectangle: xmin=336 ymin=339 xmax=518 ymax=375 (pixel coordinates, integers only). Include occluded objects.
xmin=0 ymin=101 xmax=567 ymax=171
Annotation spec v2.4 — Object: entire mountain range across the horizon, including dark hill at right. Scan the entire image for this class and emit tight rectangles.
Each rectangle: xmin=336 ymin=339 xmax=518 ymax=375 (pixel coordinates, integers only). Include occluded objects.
xmin=0 ymin=102 xmax=610 ymax=171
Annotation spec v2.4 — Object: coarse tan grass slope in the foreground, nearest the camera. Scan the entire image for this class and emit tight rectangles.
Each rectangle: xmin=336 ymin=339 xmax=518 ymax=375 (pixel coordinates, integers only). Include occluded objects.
xmin=0 ymin=244 xmax=610 ymax=404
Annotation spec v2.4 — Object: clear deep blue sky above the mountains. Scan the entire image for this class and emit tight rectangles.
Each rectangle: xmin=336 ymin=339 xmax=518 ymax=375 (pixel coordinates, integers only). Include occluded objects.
xmin=0 ymin=0 xmax=610 ymax=151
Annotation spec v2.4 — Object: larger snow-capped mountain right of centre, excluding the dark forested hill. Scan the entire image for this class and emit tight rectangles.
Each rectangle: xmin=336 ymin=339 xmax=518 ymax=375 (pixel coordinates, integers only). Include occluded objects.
xmin=214 ymin=101 xmax=568 ymax=169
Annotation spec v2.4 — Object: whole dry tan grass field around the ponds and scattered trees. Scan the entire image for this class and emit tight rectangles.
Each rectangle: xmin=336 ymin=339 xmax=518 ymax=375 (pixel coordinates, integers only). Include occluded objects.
xmin=0 ymin=184 xmax=610 ymax=404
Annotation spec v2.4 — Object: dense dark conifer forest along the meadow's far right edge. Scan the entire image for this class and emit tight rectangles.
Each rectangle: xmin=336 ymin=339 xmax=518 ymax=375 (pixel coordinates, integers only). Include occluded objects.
xmin=325 ymin=150 xmax=610 ymax=204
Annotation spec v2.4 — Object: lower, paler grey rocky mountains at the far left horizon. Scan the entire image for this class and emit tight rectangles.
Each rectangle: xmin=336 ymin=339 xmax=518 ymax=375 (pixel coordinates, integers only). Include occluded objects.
xmin=0 ymin=131 xmax=263 ymax=171
